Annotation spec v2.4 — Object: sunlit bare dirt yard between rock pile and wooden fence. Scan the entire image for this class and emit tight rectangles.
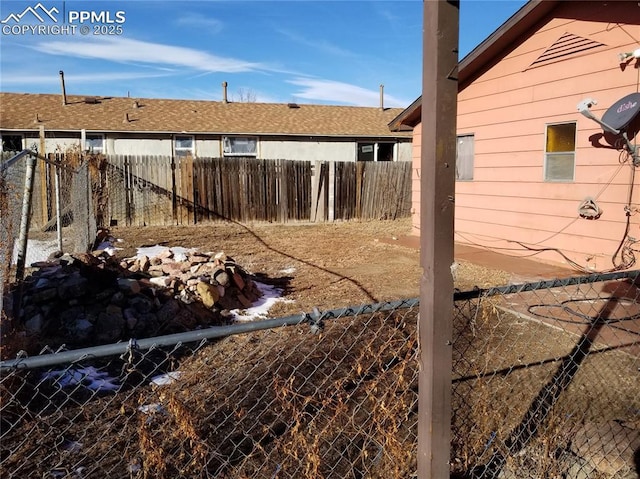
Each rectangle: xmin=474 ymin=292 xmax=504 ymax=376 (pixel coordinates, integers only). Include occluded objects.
xmin=111 ymin=219 xmax=509 ymax=317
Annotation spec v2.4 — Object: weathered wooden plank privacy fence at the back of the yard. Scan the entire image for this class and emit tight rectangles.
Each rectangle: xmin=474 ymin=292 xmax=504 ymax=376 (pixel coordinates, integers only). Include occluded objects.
xmin=27 ymin=155 xmax=411 ymax=227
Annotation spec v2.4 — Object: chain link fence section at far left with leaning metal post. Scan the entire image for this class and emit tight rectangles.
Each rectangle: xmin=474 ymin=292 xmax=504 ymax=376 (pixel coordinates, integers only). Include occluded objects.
xmin=0 ymin=150 xmax=98 ymax=329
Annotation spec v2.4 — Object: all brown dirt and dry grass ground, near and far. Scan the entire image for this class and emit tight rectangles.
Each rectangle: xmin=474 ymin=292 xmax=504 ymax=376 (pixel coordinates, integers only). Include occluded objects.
xmin=0 ymin=220 xmax=640 ymax=479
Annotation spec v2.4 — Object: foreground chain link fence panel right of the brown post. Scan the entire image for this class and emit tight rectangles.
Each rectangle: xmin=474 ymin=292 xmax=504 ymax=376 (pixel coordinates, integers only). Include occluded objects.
xmin=452 ymin=271 xmax=640 ymax=479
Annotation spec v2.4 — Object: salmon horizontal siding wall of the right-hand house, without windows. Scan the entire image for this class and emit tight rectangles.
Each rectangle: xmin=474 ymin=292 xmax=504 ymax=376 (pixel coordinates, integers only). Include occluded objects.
xmin=414 ymin=2 xmax=640 ymax=270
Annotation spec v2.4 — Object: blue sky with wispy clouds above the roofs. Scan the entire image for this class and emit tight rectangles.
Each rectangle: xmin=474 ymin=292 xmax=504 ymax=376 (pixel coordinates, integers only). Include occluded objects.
xmin=0 ymin=0 xmax=525 ymax=107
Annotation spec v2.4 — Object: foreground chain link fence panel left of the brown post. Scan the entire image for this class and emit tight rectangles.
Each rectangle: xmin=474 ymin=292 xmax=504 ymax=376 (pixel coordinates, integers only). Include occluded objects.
xmin=0 ymin=300 xmax=418 ymax=478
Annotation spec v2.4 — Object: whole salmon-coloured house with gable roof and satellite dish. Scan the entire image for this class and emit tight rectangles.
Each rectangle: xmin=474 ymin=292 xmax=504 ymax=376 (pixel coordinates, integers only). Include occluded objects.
xmin=390 ymin=1 xmax=640 ymax=271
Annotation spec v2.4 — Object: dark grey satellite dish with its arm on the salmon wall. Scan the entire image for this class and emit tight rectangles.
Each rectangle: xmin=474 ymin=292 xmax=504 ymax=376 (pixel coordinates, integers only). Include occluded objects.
xmin=578 ymin=93 xmax=640 ymax=166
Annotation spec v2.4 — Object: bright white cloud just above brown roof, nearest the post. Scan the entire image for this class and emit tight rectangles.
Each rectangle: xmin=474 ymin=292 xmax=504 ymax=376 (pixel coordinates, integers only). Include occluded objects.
xmin=287 ymin=78 xmax=408 ymax=107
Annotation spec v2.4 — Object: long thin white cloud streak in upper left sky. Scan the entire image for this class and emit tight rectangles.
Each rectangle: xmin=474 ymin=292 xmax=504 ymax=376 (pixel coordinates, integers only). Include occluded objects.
xmin=33 ymin=37 xmax=268 ymax=73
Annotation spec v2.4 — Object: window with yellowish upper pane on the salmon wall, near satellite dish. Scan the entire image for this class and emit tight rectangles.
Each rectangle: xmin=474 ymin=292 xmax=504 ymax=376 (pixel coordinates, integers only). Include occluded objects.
xmin=544 ymin=122 xmax=576 ymax=181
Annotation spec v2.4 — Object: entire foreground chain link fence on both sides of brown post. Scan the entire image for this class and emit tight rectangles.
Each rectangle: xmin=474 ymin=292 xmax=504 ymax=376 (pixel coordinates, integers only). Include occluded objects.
xmin=0 ymin=271 xmax=640 ymax=479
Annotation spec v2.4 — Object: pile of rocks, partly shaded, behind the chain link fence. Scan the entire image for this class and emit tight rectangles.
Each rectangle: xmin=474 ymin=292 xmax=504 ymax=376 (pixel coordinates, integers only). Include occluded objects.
xmin=15 ymin=244 xmax=262 ymax=347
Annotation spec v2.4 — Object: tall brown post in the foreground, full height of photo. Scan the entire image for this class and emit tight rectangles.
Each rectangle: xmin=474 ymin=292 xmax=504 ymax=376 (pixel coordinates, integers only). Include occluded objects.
xmin=418 ymin=0 xmax=459 ymax=479
